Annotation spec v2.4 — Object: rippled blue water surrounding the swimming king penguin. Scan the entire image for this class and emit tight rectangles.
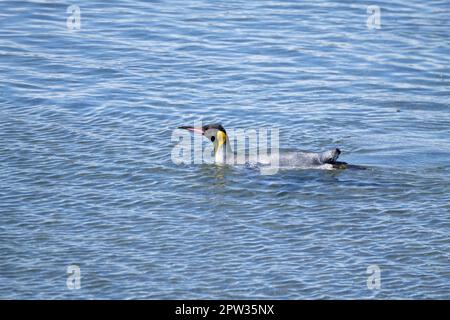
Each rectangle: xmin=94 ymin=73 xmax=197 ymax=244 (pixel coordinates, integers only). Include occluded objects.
xmin=0 ymin=0 xmax=450 ymax=299
